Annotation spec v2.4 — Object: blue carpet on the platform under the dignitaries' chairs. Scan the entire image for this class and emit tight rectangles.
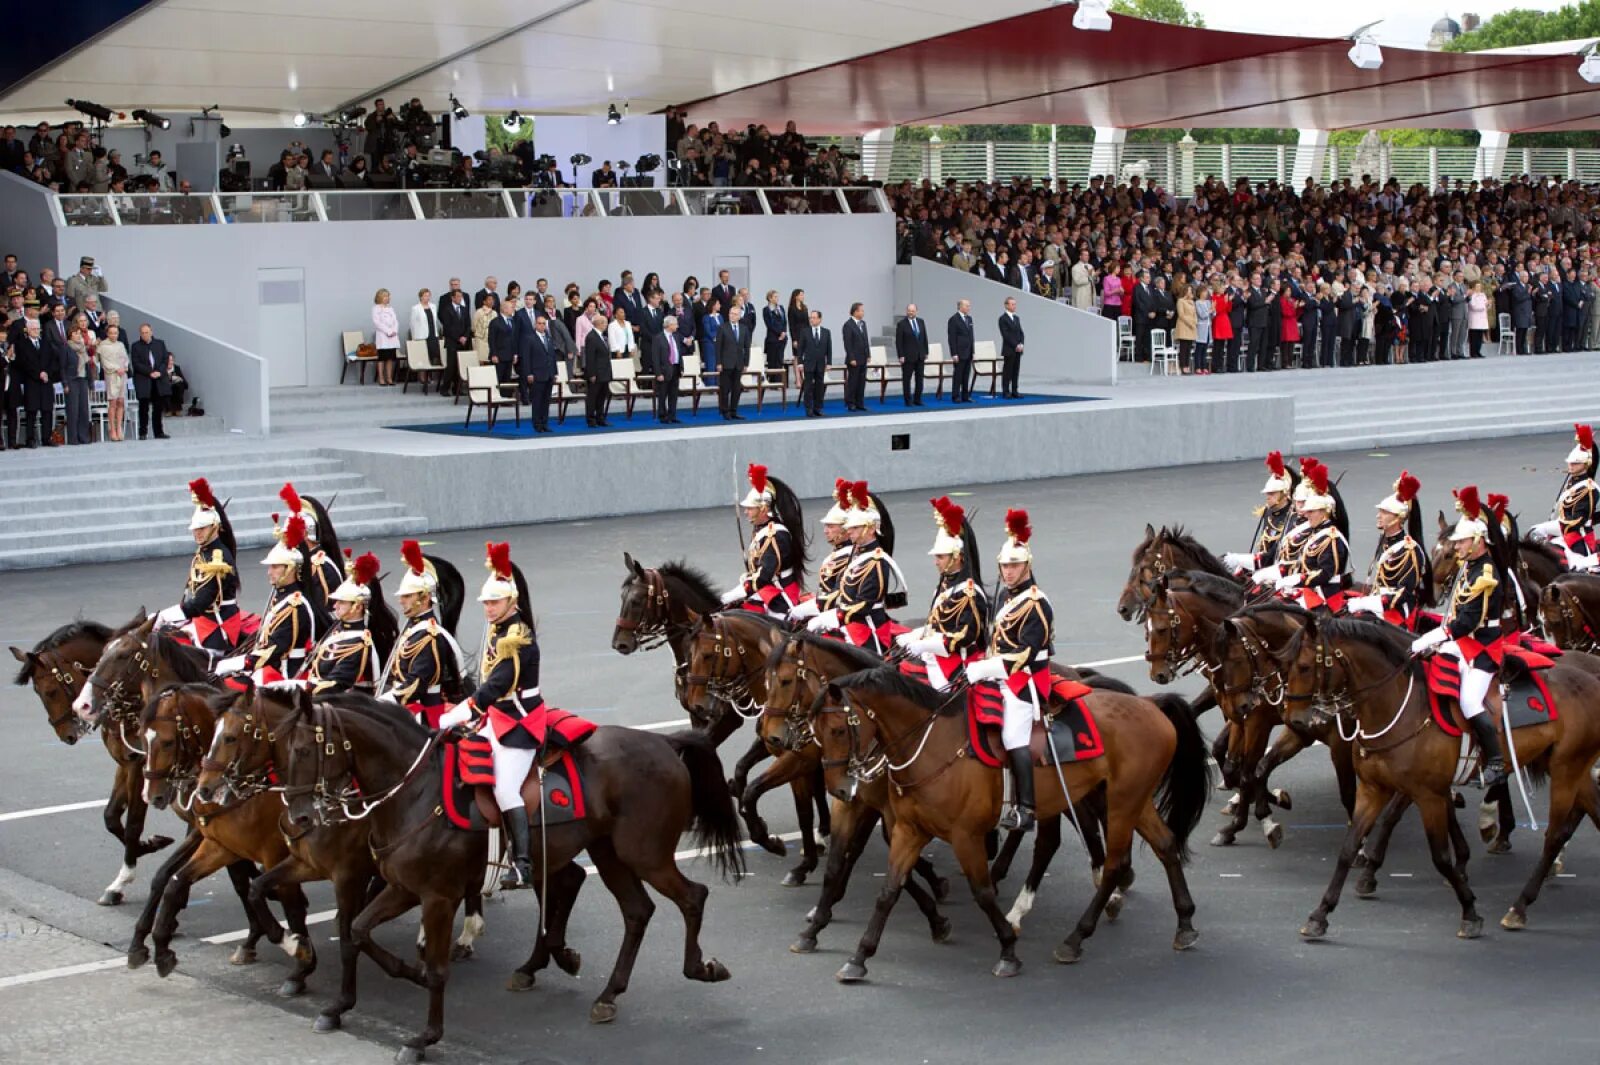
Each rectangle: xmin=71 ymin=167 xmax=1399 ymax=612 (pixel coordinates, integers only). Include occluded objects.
xmin=390 ymin=390 xmax=1094 ymax=440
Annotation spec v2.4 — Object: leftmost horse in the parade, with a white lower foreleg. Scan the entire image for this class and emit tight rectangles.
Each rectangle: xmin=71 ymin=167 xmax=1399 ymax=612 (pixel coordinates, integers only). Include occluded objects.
xmin=11 ymin=611 xmax=173 ymax=907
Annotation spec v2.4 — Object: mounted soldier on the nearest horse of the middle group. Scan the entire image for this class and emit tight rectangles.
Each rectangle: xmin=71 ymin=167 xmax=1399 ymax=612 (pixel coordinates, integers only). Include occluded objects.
xmin=966 ymin=510 xmax=1056 ymax=832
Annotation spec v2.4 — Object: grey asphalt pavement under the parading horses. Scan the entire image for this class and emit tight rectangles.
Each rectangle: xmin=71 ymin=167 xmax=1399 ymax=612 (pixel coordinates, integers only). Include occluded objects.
xmin=0 ymin=428 xmax=1600 ymax=1065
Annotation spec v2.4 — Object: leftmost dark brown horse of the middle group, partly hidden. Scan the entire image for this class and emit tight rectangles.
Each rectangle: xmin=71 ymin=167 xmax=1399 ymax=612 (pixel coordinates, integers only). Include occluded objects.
xmin=611 ymin=552 xmax=832 ymax=863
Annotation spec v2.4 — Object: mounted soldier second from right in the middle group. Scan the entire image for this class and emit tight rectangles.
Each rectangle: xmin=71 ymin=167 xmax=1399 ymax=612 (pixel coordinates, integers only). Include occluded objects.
xmin=894 ymin=496 xmax=989 ymax=691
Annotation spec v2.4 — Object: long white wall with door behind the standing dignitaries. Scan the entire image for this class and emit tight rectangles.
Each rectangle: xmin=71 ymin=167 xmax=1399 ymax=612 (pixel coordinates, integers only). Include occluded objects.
xmin=53 ymin=207 xmax=902 ymax=385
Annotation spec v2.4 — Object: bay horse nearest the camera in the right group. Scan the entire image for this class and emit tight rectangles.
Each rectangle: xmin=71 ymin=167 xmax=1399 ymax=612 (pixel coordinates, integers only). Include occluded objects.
xmin=1282 ymin=616 xmax=1600 ymax=939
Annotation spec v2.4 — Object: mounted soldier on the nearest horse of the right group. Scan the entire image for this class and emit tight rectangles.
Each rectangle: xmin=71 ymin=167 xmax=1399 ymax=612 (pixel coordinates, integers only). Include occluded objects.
xmin=1411 ymin=485 xmax=1507 ymax=788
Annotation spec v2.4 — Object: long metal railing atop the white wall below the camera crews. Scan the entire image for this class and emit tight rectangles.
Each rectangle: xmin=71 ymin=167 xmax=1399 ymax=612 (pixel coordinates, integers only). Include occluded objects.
xmin=54 ymin=185 xmax=890 ymax=225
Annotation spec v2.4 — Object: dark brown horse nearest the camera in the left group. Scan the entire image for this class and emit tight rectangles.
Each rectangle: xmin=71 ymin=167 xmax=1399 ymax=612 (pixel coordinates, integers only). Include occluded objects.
xmin=280 ymin=692 xmax=742 ymax=1062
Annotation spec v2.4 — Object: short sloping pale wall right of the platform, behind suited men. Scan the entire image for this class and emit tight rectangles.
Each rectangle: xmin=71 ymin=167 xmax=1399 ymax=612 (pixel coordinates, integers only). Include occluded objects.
xmin=896 ymin=259 xmax=1117 ymax=384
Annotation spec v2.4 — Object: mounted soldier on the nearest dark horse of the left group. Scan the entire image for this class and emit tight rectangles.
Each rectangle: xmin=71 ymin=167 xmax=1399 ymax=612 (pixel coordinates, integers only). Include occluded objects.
xmin=438 ymin=544 xmax=546 ymax=891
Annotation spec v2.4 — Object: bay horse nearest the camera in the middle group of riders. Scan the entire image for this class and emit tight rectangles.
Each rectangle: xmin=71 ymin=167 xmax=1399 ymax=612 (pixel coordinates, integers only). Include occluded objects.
xmin=795 ymin=633 xmax=1211 ymax=983
